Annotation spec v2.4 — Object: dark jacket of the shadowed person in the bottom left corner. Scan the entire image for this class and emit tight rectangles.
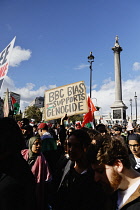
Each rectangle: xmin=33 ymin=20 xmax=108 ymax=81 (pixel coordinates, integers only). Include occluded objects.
xmin=0 ymin=154 xmax=36 ymax=210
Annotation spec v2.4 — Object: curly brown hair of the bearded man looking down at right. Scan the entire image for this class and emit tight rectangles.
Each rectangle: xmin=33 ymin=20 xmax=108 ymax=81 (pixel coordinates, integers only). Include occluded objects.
xmin=88 ymin=135 xmax=131 ymax=168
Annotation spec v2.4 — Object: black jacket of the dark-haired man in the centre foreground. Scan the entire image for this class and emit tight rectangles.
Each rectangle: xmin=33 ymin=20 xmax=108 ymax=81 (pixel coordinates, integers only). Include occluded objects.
xmin=49 ymin=158 xmax=105 ymax=210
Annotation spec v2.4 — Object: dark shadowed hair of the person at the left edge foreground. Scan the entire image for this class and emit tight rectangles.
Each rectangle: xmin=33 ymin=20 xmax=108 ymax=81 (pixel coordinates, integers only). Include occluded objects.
xmin=0 ymin=117 xmax=25 ymax=153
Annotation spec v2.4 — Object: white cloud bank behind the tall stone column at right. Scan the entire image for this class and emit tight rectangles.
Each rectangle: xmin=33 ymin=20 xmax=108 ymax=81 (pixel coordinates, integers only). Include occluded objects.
xmin=92 ymin=76 xmax=140 ymax=119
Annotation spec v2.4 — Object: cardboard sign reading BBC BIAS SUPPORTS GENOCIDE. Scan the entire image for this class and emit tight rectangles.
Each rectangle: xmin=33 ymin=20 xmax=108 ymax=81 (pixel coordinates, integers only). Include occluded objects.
xmin=44 ymin=81 xmax=88 ymax=120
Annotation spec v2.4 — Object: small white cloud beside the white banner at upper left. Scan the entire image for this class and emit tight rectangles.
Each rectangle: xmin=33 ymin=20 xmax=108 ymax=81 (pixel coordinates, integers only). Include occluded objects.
xmin=9 ymin=46 xmax=32 ymax=67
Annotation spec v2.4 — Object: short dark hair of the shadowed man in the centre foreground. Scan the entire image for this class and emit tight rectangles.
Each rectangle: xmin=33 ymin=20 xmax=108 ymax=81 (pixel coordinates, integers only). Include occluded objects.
xmin=69 ymin=129 xmax=91 ymax=147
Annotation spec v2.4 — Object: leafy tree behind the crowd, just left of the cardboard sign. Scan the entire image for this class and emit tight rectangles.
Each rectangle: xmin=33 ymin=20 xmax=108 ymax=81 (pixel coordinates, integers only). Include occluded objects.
xmin=25 ymin=106 xmax=42 ymax=122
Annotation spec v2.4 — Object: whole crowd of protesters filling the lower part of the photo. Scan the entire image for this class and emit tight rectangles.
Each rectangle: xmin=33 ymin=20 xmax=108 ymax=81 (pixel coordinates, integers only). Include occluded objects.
xmin=0 ymin=115 xmax=140 ymax=210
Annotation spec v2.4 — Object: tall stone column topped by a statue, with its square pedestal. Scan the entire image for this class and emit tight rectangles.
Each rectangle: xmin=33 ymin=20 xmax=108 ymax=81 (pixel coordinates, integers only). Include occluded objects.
xmin=110 ymin=36 xmax=128 ymax=123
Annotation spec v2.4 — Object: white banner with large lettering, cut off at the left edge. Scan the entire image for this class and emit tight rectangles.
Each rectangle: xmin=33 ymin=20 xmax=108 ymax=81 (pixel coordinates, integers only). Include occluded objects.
xmin=0 ymin=37 xmax=16 ymax=88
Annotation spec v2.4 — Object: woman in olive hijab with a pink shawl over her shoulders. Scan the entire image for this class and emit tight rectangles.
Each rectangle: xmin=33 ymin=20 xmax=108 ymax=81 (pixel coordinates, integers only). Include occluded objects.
xmin=21 ymin=136 xmax=51 ymax=210
